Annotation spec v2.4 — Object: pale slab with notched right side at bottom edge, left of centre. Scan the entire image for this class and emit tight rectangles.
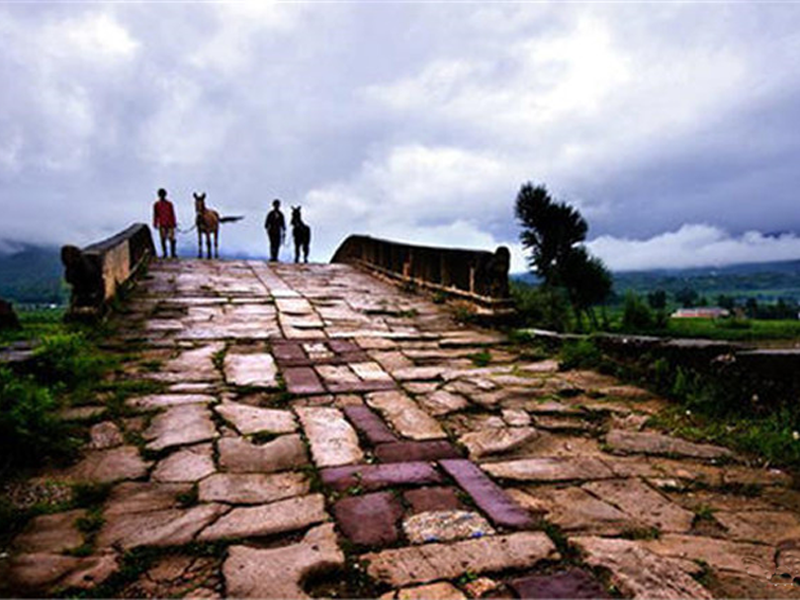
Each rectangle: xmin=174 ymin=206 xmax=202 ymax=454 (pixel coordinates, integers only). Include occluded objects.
xmin=222 ymin=524 xmax=344 ymax=598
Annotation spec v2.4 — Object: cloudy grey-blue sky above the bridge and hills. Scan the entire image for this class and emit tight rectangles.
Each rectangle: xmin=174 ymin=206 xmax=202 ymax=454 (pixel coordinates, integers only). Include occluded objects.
xmin=0 ymin=0 xmax=800 ymax=270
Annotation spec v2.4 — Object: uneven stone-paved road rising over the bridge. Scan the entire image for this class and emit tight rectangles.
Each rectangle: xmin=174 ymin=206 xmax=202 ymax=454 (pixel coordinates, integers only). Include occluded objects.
xmin=8 ymin=261 xmax=800 ymax=598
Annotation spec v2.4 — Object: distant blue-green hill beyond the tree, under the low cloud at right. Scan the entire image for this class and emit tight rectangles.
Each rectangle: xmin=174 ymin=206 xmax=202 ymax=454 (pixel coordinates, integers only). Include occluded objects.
xmin=512 ymin=260 xmax=800 ymax=304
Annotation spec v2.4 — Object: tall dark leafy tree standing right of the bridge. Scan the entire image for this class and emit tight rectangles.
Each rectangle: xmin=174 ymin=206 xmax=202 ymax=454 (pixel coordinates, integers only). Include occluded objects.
xmin=515 ymin=182 xmax=612 ymax=327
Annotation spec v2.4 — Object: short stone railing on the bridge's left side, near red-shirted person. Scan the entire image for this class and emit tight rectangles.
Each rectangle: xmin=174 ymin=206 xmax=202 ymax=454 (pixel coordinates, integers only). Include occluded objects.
xmin=61 ymin=223 xmax=155 ymax=318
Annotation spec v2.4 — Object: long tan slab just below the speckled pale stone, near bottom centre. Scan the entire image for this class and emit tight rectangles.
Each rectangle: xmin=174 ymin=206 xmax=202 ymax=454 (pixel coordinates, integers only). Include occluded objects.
xmin=362 ymin=531 xmax=558 ymax=587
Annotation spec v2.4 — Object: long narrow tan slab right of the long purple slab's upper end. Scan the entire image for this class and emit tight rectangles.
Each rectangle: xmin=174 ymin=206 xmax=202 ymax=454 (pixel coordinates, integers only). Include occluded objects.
xmin=481 ymin=456 xmax=614 ymax=481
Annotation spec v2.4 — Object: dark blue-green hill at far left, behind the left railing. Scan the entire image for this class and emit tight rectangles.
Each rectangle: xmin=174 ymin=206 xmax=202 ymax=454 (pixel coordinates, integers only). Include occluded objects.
xmin=0 ymin=245 xmax=69 ymax=305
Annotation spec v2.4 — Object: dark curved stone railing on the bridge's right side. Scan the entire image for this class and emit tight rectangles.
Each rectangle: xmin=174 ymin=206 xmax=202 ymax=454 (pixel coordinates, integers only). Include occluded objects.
xmin=331 ymin=235 xmax=511 ymax=310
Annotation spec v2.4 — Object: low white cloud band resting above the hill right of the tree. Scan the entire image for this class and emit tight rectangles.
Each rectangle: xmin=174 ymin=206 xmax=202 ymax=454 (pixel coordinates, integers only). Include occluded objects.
xmin=587 ymin=224 xmax=800 ymax=271
